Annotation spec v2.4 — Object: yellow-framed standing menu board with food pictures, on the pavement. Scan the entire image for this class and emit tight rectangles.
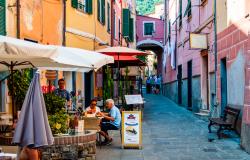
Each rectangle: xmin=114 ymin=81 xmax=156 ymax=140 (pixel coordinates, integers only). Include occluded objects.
xmin=122 ymin=111 xmax=142 ymax=149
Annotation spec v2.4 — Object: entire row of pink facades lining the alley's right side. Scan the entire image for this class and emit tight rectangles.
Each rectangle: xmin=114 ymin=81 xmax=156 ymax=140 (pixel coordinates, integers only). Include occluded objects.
xmin=163 ymin=0 xmax=250 ymax=152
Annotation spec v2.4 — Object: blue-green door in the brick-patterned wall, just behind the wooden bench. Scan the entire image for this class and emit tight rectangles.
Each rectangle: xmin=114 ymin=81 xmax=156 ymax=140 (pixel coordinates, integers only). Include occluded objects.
xmin=220 ymin=58 xmax=227 ymax=114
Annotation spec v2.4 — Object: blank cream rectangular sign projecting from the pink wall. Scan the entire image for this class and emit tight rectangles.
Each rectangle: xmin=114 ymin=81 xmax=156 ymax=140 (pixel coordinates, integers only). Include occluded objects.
xmin=189 ymin=33 xmax=208 ymax=49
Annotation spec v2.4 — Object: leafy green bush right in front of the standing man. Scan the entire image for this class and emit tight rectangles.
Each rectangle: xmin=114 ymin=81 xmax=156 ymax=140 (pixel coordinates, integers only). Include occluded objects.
xmin=44 ymin=93 xmax=65 ymax=115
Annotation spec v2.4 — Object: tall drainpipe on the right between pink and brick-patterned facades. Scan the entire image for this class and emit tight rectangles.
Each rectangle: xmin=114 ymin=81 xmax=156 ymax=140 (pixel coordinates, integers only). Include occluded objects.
xmin=214 ymin=0 xmax=217 ymax=99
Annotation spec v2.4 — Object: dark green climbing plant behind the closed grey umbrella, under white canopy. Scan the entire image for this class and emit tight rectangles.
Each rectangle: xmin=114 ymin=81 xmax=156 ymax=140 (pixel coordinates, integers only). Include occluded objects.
xmin=8 ymin=69 xmax=32 ymax=110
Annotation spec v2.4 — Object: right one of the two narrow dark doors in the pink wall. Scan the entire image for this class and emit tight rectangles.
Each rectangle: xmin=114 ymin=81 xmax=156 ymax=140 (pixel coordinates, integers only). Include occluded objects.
xmin=187 ymin=60 xmax=193 ymax=110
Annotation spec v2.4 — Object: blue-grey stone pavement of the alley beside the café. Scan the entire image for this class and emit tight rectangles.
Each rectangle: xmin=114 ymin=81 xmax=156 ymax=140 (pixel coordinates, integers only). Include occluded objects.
xmin=97 ymin=95 xmax=250 ymax=160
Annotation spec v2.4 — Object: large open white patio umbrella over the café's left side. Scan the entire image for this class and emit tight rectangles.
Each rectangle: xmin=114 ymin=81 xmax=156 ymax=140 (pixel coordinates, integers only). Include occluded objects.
xmin=0 ymin=36 xmax=114 ymax=122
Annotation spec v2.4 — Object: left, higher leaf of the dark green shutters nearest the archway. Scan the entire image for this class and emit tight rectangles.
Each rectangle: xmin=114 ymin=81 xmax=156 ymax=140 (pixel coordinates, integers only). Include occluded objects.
xmin=122 ymin=9 xmax=130 ymax=37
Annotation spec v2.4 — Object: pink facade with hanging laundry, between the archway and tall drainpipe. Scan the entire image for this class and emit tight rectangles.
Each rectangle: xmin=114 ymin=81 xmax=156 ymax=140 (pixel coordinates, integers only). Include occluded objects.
xmin=162 ymin=0 xmax=215 ymax=112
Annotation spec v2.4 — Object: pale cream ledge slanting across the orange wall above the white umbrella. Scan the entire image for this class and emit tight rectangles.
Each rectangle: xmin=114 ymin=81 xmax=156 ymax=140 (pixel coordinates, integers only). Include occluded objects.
xmin=66 ymin=27 xmax=108 ymax=44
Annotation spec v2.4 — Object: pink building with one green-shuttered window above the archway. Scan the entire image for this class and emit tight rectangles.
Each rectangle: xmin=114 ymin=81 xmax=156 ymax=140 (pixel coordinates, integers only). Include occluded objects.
xmin=136 ymin=15 xmax=164 ymax=74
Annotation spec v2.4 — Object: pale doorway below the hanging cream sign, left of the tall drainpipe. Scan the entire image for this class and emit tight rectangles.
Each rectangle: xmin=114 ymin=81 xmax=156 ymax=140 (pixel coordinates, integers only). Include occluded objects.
xmin=201 ymin=54 xmax=209 ymax=110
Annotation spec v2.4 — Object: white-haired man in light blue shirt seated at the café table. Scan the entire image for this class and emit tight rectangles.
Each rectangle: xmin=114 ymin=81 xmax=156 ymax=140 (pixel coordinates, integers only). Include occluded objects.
xmin=100 ymin=99 xmax=121 ymax=145
